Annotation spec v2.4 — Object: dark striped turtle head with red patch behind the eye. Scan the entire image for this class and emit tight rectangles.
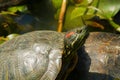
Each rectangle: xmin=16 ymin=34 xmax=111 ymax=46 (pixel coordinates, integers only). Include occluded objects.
xmin=64 ymin=26 xmax=89 ymax=55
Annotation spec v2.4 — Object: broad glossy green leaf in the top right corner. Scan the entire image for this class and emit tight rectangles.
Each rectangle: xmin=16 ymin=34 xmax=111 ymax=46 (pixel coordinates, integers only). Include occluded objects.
xmin=99 ymin=0 xmax=120 ymax=18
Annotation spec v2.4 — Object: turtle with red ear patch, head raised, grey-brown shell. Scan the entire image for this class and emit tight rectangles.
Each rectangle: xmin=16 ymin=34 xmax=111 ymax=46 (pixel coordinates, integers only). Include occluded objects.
xmin=0 ymin=27 xmax=88 ymax=80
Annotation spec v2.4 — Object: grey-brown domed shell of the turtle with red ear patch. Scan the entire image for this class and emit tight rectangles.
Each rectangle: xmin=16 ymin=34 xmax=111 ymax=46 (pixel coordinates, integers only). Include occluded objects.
xmin=0 ymin=31 xmax=64 ymax=80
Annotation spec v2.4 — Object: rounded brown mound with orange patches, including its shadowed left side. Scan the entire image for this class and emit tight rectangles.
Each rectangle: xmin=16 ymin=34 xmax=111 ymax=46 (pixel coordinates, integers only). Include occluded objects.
xmin=67 ymin=32 xmax=120 ymax=80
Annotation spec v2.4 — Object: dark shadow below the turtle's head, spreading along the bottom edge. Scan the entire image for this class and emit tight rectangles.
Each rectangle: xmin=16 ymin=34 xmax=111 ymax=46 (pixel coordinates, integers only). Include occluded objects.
xmin=67 ymin=46 xmax=119 ymax=80
